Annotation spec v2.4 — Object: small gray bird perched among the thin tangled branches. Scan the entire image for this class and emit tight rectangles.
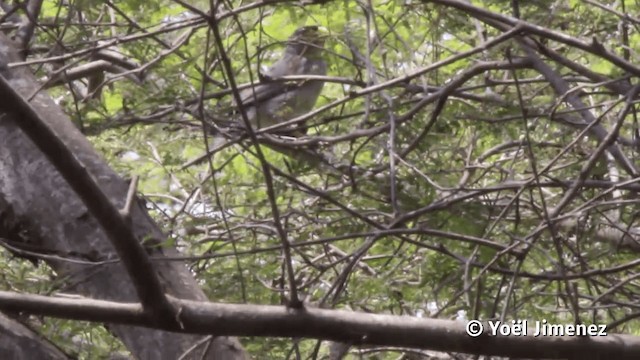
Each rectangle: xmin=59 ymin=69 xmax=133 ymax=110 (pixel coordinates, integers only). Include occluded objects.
xmin=240 ymin=26 xmax=327 ymax=135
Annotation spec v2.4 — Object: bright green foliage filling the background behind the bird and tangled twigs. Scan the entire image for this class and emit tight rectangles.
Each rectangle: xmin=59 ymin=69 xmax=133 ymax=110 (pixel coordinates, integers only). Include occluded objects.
xmin=7 ymin=1 xmax=640 ymax=358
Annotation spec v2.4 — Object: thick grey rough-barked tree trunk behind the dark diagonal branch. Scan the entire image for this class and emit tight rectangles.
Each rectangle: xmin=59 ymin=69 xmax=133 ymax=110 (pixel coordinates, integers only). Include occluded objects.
xmin=0 ymin=35 xmax=246 ymax=359
